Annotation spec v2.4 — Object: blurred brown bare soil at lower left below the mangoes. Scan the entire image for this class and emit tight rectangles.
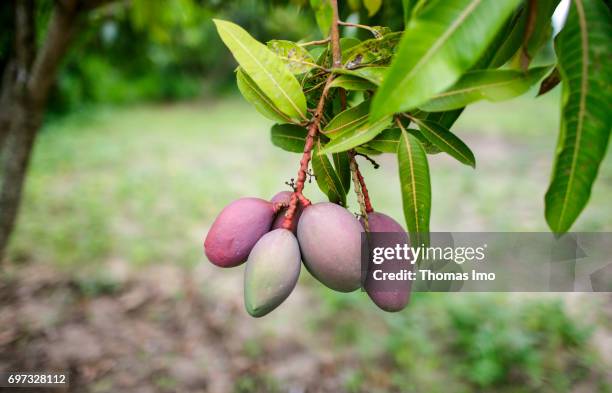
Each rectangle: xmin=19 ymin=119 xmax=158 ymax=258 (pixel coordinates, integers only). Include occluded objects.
xmin=0 ymin=262 xmax=364 ymax=393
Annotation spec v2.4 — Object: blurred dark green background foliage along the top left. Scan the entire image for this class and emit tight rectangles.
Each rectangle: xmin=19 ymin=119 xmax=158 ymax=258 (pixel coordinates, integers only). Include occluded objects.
xmin=0 ymin=0 xmax=403 ymax=118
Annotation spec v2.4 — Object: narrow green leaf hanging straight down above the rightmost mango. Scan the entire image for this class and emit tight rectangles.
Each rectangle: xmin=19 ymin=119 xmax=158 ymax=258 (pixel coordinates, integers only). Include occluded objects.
xmin=397 ymin=131 xmax=431 ymax=246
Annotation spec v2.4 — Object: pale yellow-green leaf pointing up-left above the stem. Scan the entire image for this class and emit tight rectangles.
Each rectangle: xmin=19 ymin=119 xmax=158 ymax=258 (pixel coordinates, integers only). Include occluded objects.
xmin=214 ymin=19 xmax=307 ymax=120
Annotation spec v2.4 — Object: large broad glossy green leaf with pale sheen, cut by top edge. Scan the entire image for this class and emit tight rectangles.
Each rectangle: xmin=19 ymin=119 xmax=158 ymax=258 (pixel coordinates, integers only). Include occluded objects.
xmin=370 ymin=0 xmax=521 ymax=122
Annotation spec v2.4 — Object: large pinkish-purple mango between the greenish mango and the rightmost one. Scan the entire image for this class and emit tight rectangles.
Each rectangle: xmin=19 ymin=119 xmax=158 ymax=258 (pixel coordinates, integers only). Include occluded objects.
xmin=297 ymin=202 xmax=363 ymax=292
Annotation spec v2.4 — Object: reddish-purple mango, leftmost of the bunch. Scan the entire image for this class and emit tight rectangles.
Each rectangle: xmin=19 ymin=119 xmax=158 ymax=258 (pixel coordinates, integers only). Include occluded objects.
xmin=204 ymin=198 xmax=274 ymax=267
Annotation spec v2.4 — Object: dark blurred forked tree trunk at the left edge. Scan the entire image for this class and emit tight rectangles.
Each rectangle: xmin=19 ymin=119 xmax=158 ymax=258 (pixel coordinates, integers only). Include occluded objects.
xmin=0 ymin=0 xmax=80 ymax=263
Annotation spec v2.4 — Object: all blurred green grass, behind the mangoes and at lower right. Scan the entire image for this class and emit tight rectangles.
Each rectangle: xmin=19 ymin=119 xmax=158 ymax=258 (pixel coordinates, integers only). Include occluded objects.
xmin=5 ymin=89 xmax=612 ymax=392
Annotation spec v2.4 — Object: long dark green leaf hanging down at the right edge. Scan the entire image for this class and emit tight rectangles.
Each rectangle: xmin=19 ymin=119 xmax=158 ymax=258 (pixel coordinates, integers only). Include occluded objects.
xmin=545 ymin=0 xmax=612 ymax=233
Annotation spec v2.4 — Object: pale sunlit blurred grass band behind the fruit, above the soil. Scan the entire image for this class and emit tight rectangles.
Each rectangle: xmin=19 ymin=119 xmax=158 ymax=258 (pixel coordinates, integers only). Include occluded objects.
xmin=10 ymin=87 xmax=612 ymax=267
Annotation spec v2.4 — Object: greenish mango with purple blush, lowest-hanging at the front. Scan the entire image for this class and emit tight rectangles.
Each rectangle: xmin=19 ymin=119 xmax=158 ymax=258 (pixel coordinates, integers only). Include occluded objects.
xmin=244 ymin=228 xmax=301 ymax=318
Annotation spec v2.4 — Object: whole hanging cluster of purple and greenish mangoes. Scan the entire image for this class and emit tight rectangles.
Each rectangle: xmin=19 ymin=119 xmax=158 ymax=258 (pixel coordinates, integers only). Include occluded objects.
xmin=204 ymin=191 xmax=410 ymax=317
